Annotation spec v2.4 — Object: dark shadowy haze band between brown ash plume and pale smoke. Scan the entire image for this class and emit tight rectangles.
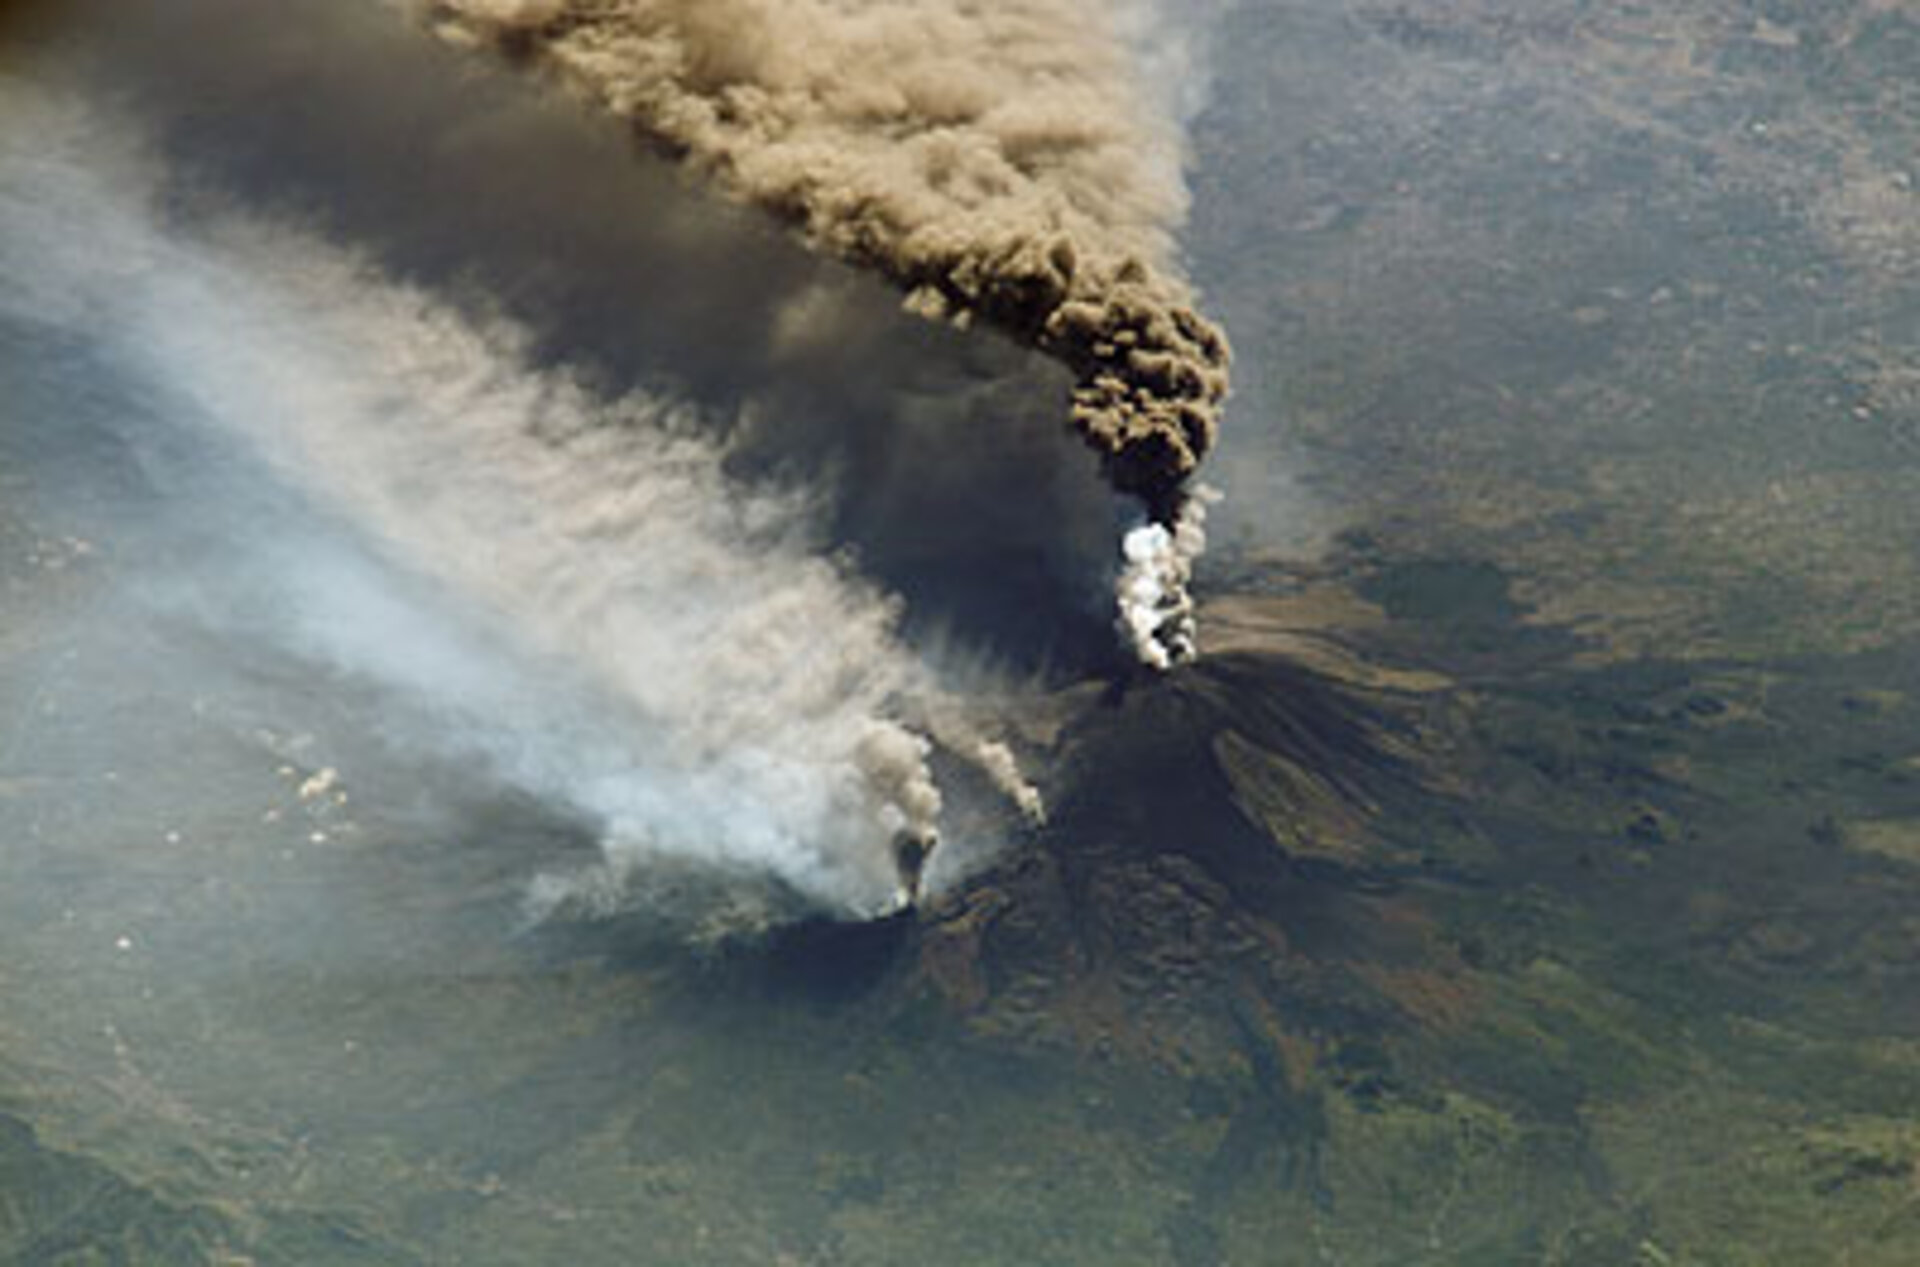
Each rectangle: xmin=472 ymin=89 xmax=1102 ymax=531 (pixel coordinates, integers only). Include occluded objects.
xmin=58 ymin=0 xmax=1136 ymax=676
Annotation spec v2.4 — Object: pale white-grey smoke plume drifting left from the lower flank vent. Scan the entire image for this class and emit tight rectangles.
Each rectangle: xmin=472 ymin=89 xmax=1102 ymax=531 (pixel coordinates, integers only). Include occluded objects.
xmin=0 ymin=83 xmax=1044 ymax=914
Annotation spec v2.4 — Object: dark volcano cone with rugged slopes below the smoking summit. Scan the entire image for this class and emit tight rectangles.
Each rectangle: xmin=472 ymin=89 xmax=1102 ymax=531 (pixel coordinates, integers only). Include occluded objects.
xmin=706 ymin=651 xmax=1444 ymax=1069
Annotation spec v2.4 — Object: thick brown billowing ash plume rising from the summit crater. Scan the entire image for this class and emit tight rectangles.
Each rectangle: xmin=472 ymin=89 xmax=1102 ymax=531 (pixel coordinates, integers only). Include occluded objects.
xmin=428 ymin=0 xmax=1229 ymax=662
